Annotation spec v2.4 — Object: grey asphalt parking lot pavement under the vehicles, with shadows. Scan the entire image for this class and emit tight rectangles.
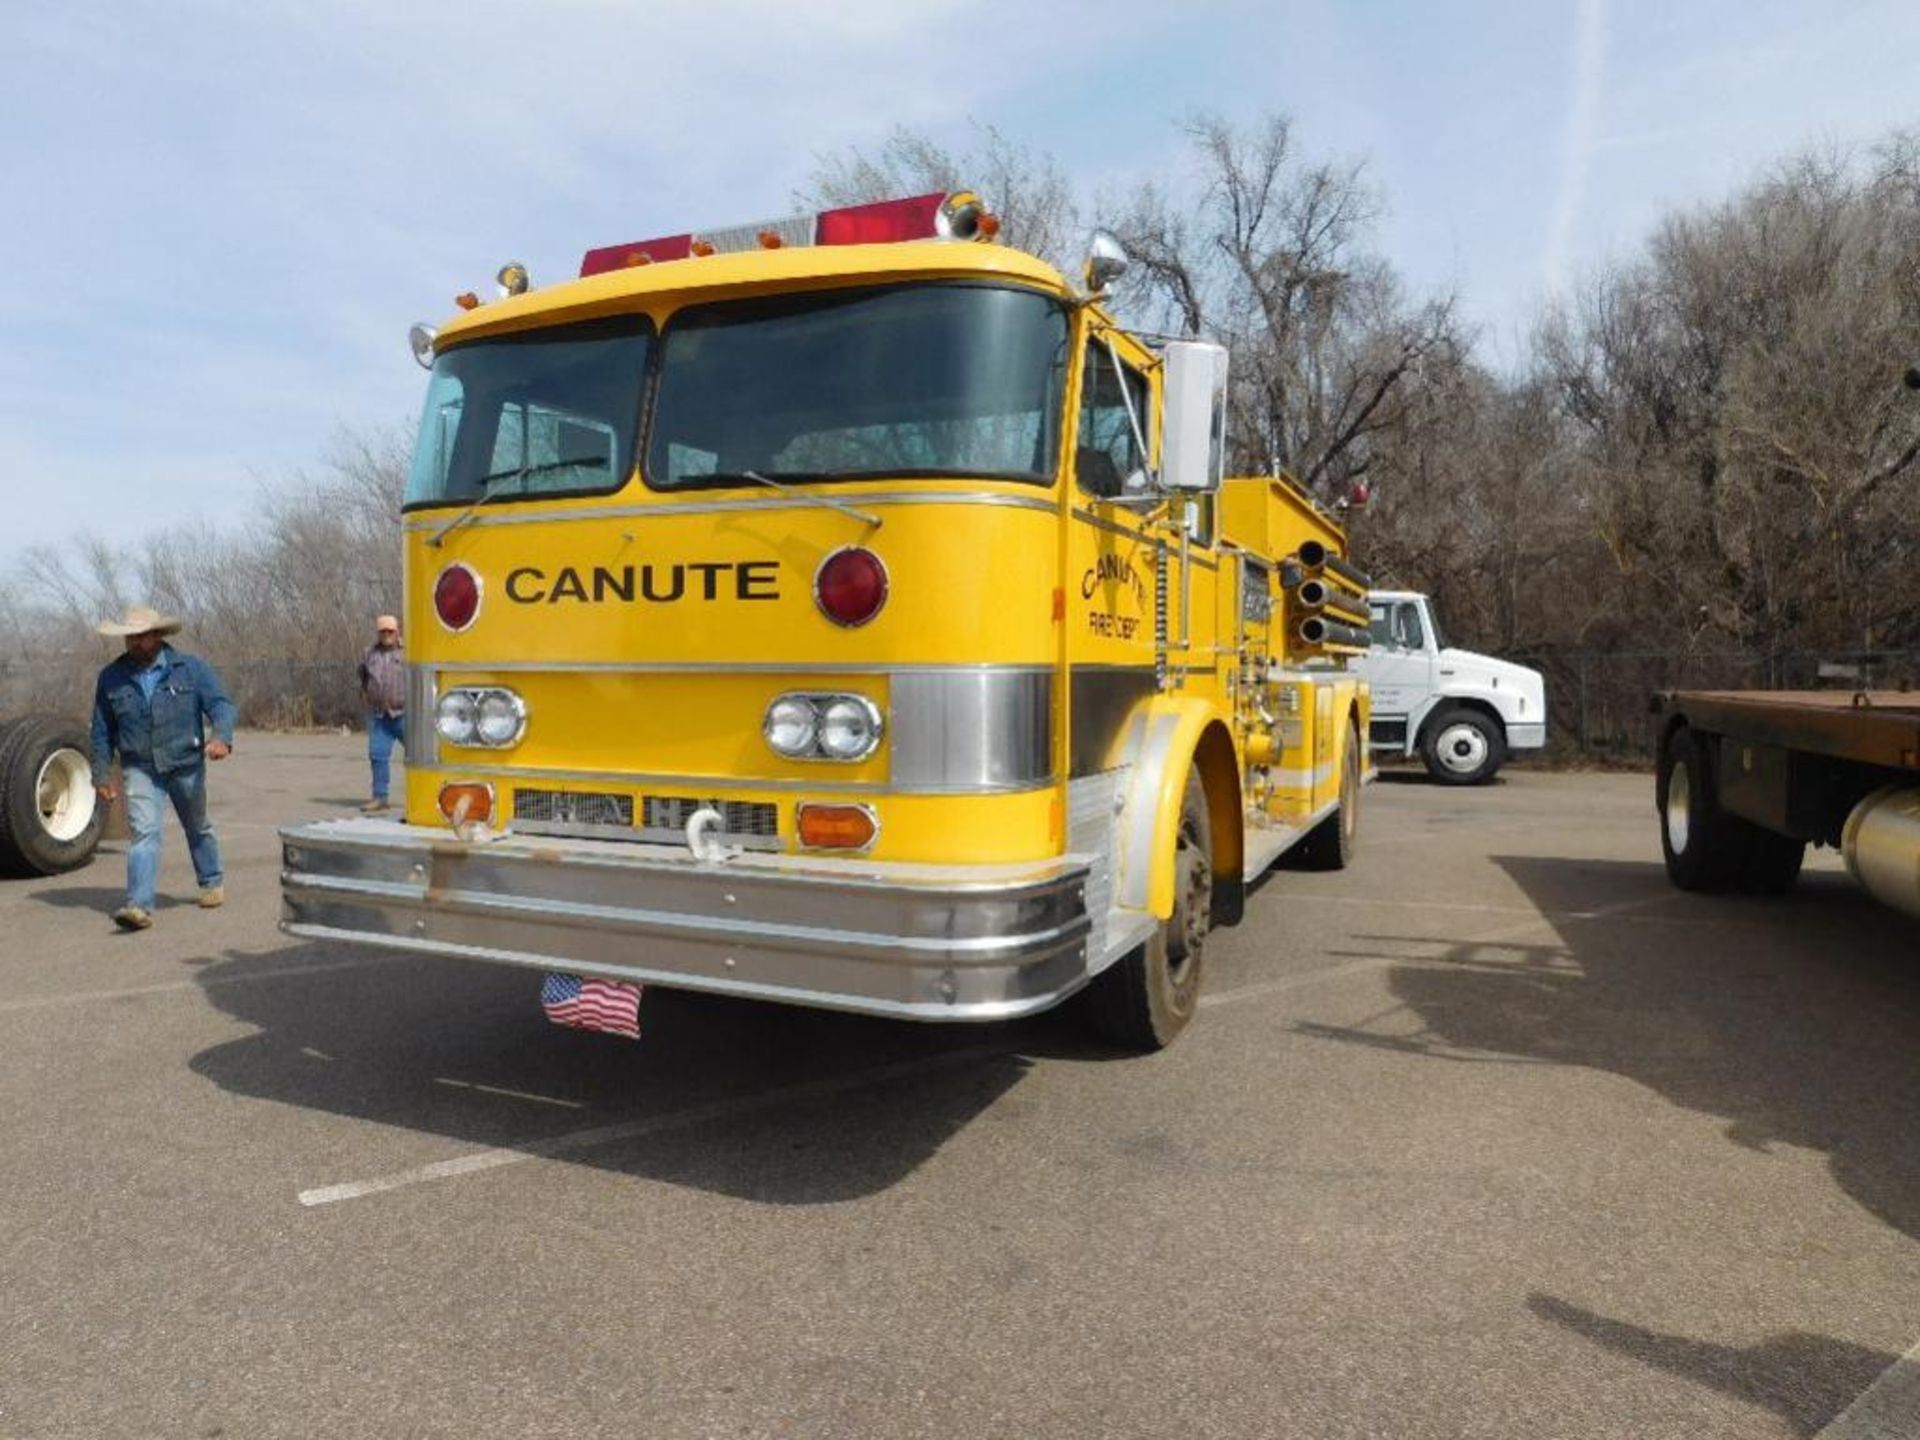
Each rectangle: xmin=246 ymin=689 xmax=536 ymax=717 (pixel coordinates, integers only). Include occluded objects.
xmin=0 ymin=733 xmax=1920 ymax=1440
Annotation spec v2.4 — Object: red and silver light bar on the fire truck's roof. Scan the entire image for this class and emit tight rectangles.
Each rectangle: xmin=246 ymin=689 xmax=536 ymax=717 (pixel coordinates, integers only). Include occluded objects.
xmin=580 ymin=190 xmax=1000 ymax=275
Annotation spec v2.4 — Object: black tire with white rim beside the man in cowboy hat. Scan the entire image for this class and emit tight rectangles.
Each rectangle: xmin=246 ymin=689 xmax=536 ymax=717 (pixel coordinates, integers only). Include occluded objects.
xmin=0 ymin=714 xmax=108 ymax=876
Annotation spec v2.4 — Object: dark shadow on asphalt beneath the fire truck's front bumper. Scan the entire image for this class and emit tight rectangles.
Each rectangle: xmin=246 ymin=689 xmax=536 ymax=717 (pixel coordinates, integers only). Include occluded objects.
xmin=190 ymin=943 xmax=1092 ymax=1204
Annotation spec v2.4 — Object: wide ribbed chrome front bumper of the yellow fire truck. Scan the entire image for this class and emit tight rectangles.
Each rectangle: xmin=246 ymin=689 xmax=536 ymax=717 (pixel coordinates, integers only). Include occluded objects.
xmin=280 ymin=820 xmax=1091 ymax=1020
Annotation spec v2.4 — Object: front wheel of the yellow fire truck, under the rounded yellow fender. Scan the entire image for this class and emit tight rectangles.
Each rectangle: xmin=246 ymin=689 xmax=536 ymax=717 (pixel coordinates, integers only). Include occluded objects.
xmin=1085 ymin=770 xmax=1213 ymax=1052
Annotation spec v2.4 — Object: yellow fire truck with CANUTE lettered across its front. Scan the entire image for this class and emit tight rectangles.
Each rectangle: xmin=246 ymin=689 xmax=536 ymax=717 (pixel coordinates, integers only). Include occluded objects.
xmin=282 ymin=192 xmax=1369 ymax=1048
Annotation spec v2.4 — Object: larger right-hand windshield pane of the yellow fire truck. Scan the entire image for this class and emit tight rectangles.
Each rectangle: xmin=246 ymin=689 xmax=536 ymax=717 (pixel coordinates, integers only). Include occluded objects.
xmin=645 ymin=284 xmax=1068 ymax=490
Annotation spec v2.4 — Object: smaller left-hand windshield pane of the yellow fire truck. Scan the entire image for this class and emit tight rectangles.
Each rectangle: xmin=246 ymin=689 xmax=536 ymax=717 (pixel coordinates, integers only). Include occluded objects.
xmin=405 ymin=315 xmax=653 ymax=509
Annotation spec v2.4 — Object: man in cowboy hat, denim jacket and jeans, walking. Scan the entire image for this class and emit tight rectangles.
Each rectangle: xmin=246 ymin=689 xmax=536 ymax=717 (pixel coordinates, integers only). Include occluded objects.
xmin=92 ymin=605 xmax=234 ymax=929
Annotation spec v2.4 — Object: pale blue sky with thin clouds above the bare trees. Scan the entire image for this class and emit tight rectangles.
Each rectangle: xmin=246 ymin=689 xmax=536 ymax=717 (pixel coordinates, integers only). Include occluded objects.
xmin=0 ymin=0 xmax=1920 ymax=568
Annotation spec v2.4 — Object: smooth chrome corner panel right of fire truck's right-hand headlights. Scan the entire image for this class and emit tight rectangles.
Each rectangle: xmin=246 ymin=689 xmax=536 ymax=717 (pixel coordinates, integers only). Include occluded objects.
xmin=887 ymin=670 xmax=1054 ymax=795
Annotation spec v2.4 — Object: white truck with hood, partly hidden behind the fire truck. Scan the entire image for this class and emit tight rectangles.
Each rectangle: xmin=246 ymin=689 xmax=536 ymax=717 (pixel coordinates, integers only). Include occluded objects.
xmin=1356 ymin=589 xmax=1548 ymax=785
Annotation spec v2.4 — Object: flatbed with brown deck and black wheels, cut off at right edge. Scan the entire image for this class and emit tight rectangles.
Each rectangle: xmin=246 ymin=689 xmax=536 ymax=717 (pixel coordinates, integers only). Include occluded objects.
xmin=1653 ymin=691 xmax=1920 ymax=914
